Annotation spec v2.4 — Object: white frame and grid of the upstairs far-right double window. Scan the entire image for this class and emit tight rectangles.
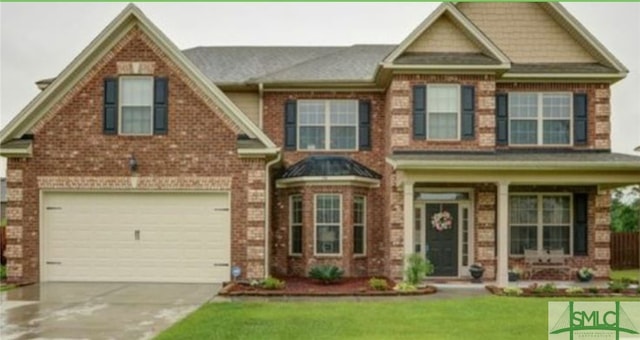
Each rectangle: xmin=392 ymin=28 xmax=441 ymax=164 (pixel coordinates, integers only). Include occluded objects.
xmin=507 ymin=91 xmax=573 ymax=147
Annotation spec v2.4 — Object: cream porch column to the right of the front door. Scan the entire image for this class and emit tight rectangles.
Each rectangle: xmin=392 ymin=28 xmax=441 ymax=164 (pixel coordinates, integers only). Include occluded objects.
xmin=496 ymin=182 xmax=509 ymax=287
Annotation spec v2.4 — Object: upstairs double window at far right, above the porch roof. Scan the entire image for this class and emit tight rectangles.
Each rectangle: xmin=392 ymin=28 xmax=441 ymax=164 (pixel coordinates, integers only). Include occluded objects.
xmin=509 ymin=92 xmax=573 ymax=145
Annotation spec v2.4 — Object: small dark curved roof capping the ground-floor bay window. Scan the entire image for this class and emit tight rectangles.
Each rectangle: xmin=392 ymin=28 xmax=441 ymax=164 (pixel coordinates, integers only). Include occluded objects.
xmin=281 ymin=156 xmax=382 ymax=179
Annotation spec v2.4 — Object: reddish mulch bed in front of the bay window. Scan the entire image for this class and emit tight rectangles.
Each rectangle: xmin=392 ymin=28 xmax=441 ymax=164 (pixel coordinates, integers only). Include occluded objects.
xmin=218 ymin=277 xmax=437 ymax=296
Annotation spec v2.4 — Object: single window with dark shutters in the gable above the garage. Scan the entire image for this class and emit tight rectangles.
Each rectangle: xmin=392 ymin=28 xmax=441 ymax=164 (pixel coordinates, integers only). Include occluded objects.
xmin=119 ymin=77 xmax=153 ymax=135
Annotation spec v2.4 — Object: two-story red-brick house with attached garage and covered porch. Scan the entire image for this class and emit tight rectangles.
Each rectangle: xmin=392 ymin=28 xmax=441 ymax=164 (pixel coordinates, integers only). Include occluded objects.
xmin=0 ymin=3 xmax=640 ymax=284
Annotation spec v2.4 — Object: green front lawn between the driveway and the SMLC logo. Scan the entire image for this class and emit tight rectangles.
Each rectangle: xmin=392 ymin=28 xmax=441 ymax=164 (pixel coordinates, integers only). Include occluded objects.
xmin=157 ymin=296 xmax=636 ymax=340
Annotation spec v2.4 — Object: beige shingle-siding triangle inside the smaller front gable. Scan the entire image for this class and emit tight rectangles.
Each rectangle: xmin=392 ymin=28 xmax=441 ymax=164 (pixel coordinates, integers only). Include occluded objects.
xmin=406 ymin=16 xmax=480 ymax=53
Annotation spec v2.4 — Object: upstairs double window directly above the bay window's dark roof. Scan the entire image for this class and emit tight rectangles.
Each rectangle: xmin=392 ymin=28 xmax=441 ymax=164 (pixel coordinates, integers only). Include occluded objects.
xmin=298 ymin=100 xmax=358 ymax=150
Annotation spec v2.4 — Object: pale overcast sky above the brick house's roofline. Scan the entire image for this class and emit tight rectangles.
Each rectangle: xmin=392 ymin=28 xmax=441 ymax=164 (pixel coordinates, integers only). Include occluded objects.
xmin=0 ymin=2 xmax=640 ymax=176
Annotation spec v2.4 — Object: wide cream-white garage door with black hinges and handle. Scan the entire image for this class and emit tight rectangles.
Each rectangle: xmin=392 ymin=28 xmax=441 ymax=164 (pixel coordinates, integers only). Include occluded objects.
xmin=42 ymin=192 xmax=231 ymax=282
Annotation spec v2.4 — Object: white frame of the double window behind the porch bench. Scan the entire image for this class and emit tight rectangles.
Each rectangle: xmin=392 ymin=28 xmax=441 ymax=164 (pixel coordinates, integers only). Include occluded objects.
xmin=508 ymin=192 xmax=574 ymax=257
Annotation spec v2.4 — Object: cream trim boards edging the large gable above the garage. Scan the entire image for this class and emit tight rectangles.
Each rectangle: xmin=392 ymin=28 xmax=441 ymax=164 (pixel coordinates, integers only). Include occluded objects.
xmin=0 ymin=4 xmax=277 ymax=153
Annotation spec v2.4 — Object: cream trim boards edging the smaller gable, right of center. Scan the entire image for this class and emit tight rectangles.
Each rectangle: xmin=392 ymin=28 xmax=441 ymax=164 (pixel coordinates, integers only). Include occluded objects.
xmin=383 ymin=2 xmax=509 ymax=69
